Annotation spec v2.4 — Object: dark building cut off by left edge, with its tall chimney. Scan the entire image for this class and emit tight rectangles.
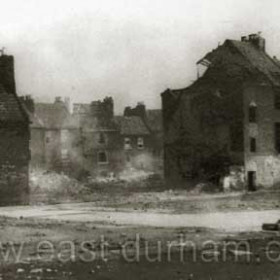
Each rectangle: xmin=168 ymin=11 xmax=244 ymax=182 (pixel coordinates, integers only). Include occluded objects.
xmin=0 ymin=54 xmax=30 ymax=204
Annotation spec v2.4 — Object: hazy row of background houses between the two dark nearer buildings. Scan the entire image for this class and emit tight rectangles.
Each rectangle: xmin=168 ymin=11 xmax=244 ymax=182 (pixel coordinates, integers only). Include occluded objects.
xmin=22 ymin=96 xmax=163 ymax=178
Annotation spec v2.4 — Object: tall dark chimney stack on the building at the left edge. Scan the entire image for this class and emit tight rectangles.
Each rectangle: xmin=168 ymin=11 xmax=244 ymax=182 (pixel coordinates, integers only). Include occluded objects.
xmin=0 ymin=54 xmax=16 ymax=94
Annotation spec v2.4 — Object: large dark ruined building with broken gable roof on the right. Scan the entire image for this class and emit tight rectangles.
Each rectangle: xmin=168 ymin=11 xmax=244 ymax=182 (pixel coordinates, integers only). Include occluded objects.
xmin=162 ymin=34 xmax=280 ymax=190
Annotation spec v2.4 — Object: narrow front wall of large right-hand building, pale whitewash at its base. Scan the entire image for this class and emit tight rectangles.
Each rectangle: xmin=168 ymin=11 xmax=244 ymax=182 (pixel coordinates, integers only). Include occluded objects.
xmin=244 ymin=84 xmax=280 ymax=187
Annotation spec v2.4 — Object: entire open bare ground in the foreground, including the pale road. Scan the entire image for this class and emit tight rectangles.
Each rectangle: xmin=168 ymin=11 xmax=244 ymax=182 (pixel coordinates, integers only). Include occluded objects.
xmin=0 ymin=193 xmax=280 ymax=280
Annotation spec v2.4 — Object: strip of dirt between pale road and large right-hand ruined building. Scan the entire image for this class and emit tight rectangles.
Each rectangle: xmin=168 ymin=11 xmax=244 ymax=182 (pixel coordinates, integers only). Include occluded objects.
xmin=80 ymin=189 xmax=280 ymax=213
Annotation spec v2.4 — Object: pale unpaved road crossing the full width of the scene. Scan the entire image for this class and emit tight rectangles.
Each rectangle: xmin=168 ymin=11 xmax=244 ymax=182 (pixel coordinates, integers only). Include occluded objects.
xmin=0 ymin=203 xmax=280 ymax=232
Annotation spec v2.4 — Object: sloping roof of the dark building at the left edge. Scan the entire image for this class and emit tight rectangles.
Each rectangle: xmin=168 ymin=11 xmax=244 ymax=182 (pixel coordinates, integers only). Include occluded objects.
xmin=0 ymin=85 xmax=28 ymax=122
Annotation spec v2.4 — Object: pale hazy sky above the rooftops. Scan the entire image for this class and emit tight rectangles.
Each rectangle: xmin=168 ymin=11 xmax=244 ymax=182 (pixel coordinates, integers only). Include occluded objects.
xmin=0 ymin=0 xmax=280 ymax=113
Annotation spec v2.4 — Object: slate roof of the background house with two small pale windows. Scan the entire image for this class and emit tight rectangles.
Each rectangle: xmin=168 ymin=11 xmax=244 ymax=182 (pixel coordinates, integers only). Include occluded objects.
xmin=114 ymin=116 xmax=150 ymax=136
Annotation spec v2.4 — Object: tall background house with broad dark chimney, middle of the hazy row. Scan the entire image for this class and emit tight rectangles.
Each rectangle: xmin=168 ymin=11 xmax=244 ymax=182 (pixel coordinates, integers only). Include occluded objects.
xmin=77 ymin=97 xmax=121 ymax=177
